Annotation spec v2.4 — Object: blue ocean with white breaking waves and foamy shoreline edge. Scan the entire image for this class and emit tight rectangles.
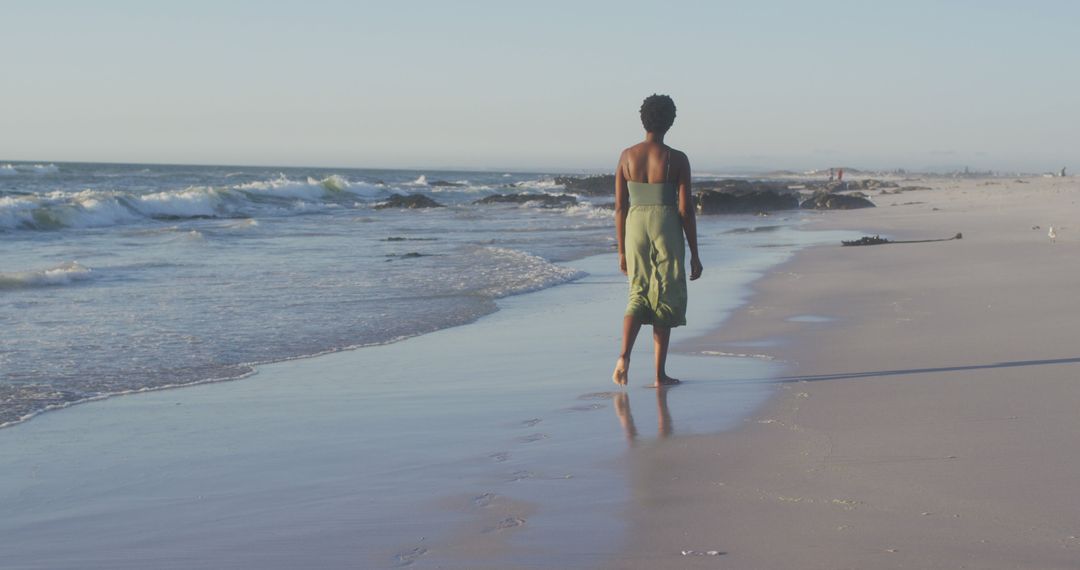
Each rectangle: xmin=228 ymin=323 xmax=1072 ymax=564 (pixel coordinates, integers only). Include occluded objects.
xmin=0 ymin=163 xmax=626 ymax=425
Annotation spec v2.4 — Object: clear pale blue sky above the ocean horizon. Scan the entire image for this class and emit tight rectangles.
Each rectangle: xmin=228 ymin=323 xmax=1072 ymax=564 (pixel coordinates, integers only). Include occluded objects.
xmin=0 ymin=0 xmax=1080 ymax=171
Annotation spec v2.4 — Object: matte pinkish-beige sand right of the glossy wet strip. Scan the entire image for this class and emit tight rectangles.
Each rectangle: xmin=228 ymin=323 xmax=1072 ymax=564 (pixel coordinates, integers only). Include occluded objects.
xmin=611 ymin=178 xmax=1080 ymax=569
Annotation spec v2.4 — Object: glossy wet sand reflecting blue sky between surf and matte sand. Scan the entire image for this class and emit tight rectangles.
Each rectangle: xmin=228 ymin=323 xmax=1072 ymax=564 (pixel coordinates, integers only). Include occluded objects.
xmin=0 ymin=212 xmax=851 ymax=568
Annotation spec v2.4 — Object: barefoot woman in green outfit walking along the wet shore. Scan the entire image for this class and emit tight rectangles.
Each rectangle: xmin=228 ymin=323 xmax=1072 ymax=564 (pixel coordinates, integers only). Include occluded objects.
xmin=611 ymin=95 xmax=702 ymax=386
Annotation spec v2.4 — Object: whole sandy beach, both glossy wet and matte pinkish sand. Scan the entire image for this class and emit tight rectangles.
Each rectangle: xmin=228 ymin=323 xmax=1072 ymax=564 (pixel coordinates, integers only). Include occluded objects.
xmin=0 ymin=178 xmax=1080 ymax=569
